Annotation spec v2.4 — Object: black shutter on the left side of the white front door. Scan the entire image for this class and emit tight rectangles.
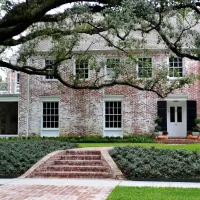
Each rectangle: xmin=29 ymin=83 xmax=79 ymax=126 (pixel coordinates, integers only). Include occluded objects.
xmin=157 ymin=101 xmax=167 ymax=131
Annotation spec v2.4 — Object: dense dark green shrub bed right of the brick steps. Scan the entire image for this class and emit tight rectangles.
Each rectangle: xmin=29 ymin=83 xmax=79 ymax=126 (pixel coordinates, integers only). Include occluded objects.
xmin=110 ymin=146 xmax=200 ymax=180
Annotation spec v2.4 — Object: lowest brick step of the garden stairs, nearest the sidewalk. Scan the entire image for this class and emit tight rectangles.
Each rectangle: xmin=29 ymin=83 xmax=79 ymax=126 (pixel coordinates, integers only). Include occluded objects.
xmin=34 ymin=171 xmax=113 ymax=179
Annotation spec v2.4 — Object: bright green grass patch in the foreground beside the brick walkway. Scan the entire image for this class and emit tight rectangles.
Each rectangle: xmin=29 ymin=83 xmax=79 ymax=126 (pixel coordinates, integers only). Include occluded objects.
xmin=107 ymin=186 xmax=200 ymax=200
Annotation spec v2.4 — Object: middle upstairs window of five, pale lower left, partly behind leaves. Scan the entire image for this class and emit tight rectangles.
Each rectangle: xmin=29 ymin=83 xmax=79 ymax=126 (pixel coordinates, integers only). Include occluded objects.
xmin=106 ymin=58 xmax=120 ymax=79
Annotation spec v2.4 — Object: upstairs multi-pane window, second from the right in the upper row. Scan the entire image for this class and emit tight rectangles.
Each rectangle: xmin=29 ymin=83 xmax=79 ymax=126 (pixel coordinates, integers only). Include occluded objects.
xmin=138 ymin=58 xmax=152 ymax=78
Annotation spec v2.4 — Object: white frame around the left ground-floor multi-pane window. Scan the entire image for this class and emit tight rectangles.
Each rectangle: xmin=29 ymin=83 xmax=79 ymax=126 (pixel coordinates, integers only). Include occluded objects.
xmin=40 ymin=96 xmax=60 ymax=131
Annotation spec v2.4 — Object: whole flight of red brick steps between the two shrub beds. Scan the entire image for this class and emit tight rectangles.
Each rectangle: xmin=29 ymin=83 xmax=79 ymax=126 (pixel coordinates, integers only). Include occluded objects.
xmin=29 ymin=150 xmax=113 ymax=178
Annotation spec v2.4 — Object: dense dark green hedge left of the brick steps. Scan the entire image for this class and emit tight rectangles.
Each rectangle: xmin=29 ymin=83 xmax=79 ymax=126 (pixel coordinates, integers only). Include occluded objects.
xmin=0 ymin=140 xmax=77 ymax=176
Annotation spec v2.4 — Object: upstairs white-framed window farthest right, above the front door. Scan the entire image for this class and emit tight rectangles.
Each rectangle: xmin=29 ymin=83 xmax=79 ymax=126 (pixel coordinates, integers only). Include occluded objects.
xmin=169 ymin=57 xmax=183 ymax=77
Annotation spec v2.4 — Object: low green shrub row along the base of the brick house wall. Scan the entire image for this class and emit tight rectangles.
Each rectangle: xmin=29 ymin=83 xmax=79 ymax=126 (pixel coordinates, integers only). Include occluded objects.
xmin=0 ymin=135 xmax=154 ymax=143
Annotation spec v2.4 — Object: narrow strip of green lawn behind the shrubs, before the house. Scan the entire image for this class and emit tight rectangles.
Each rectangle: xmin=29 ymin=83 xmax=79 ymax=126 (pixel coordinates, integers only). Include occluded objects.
xmin=78 ymin=143 xmax=200 ymax=152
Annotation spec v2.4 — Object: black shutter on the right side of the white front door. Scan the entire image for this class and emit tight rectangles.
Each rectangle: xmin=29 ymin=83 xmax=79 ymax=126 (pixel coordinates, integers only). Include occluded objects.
xmin=187 ymin=100 xmax=197 ymax=131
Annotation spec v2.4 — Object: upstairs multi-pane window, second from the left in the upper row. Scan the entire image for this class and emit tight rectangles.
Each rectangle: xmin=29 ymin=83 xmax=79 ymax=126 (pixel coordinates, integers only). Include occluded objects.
xmin=75 ymin=60 xmax=89 ymax=79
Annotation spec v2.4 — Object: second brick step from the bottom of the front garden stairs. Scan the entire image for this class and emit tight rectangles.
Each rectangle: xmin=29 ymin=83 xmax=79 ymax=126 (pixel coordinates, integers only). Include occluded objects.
xmin=46 ymin=165 xmax=110 ymax=172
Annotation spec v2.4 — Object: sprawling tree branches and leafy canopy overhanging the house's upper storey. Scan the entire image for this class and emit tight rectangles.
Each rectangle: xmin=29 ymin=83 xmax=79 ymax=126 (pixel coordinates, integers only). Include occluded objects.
xmin=0 ymin=0 xmax=200 ymax=97
